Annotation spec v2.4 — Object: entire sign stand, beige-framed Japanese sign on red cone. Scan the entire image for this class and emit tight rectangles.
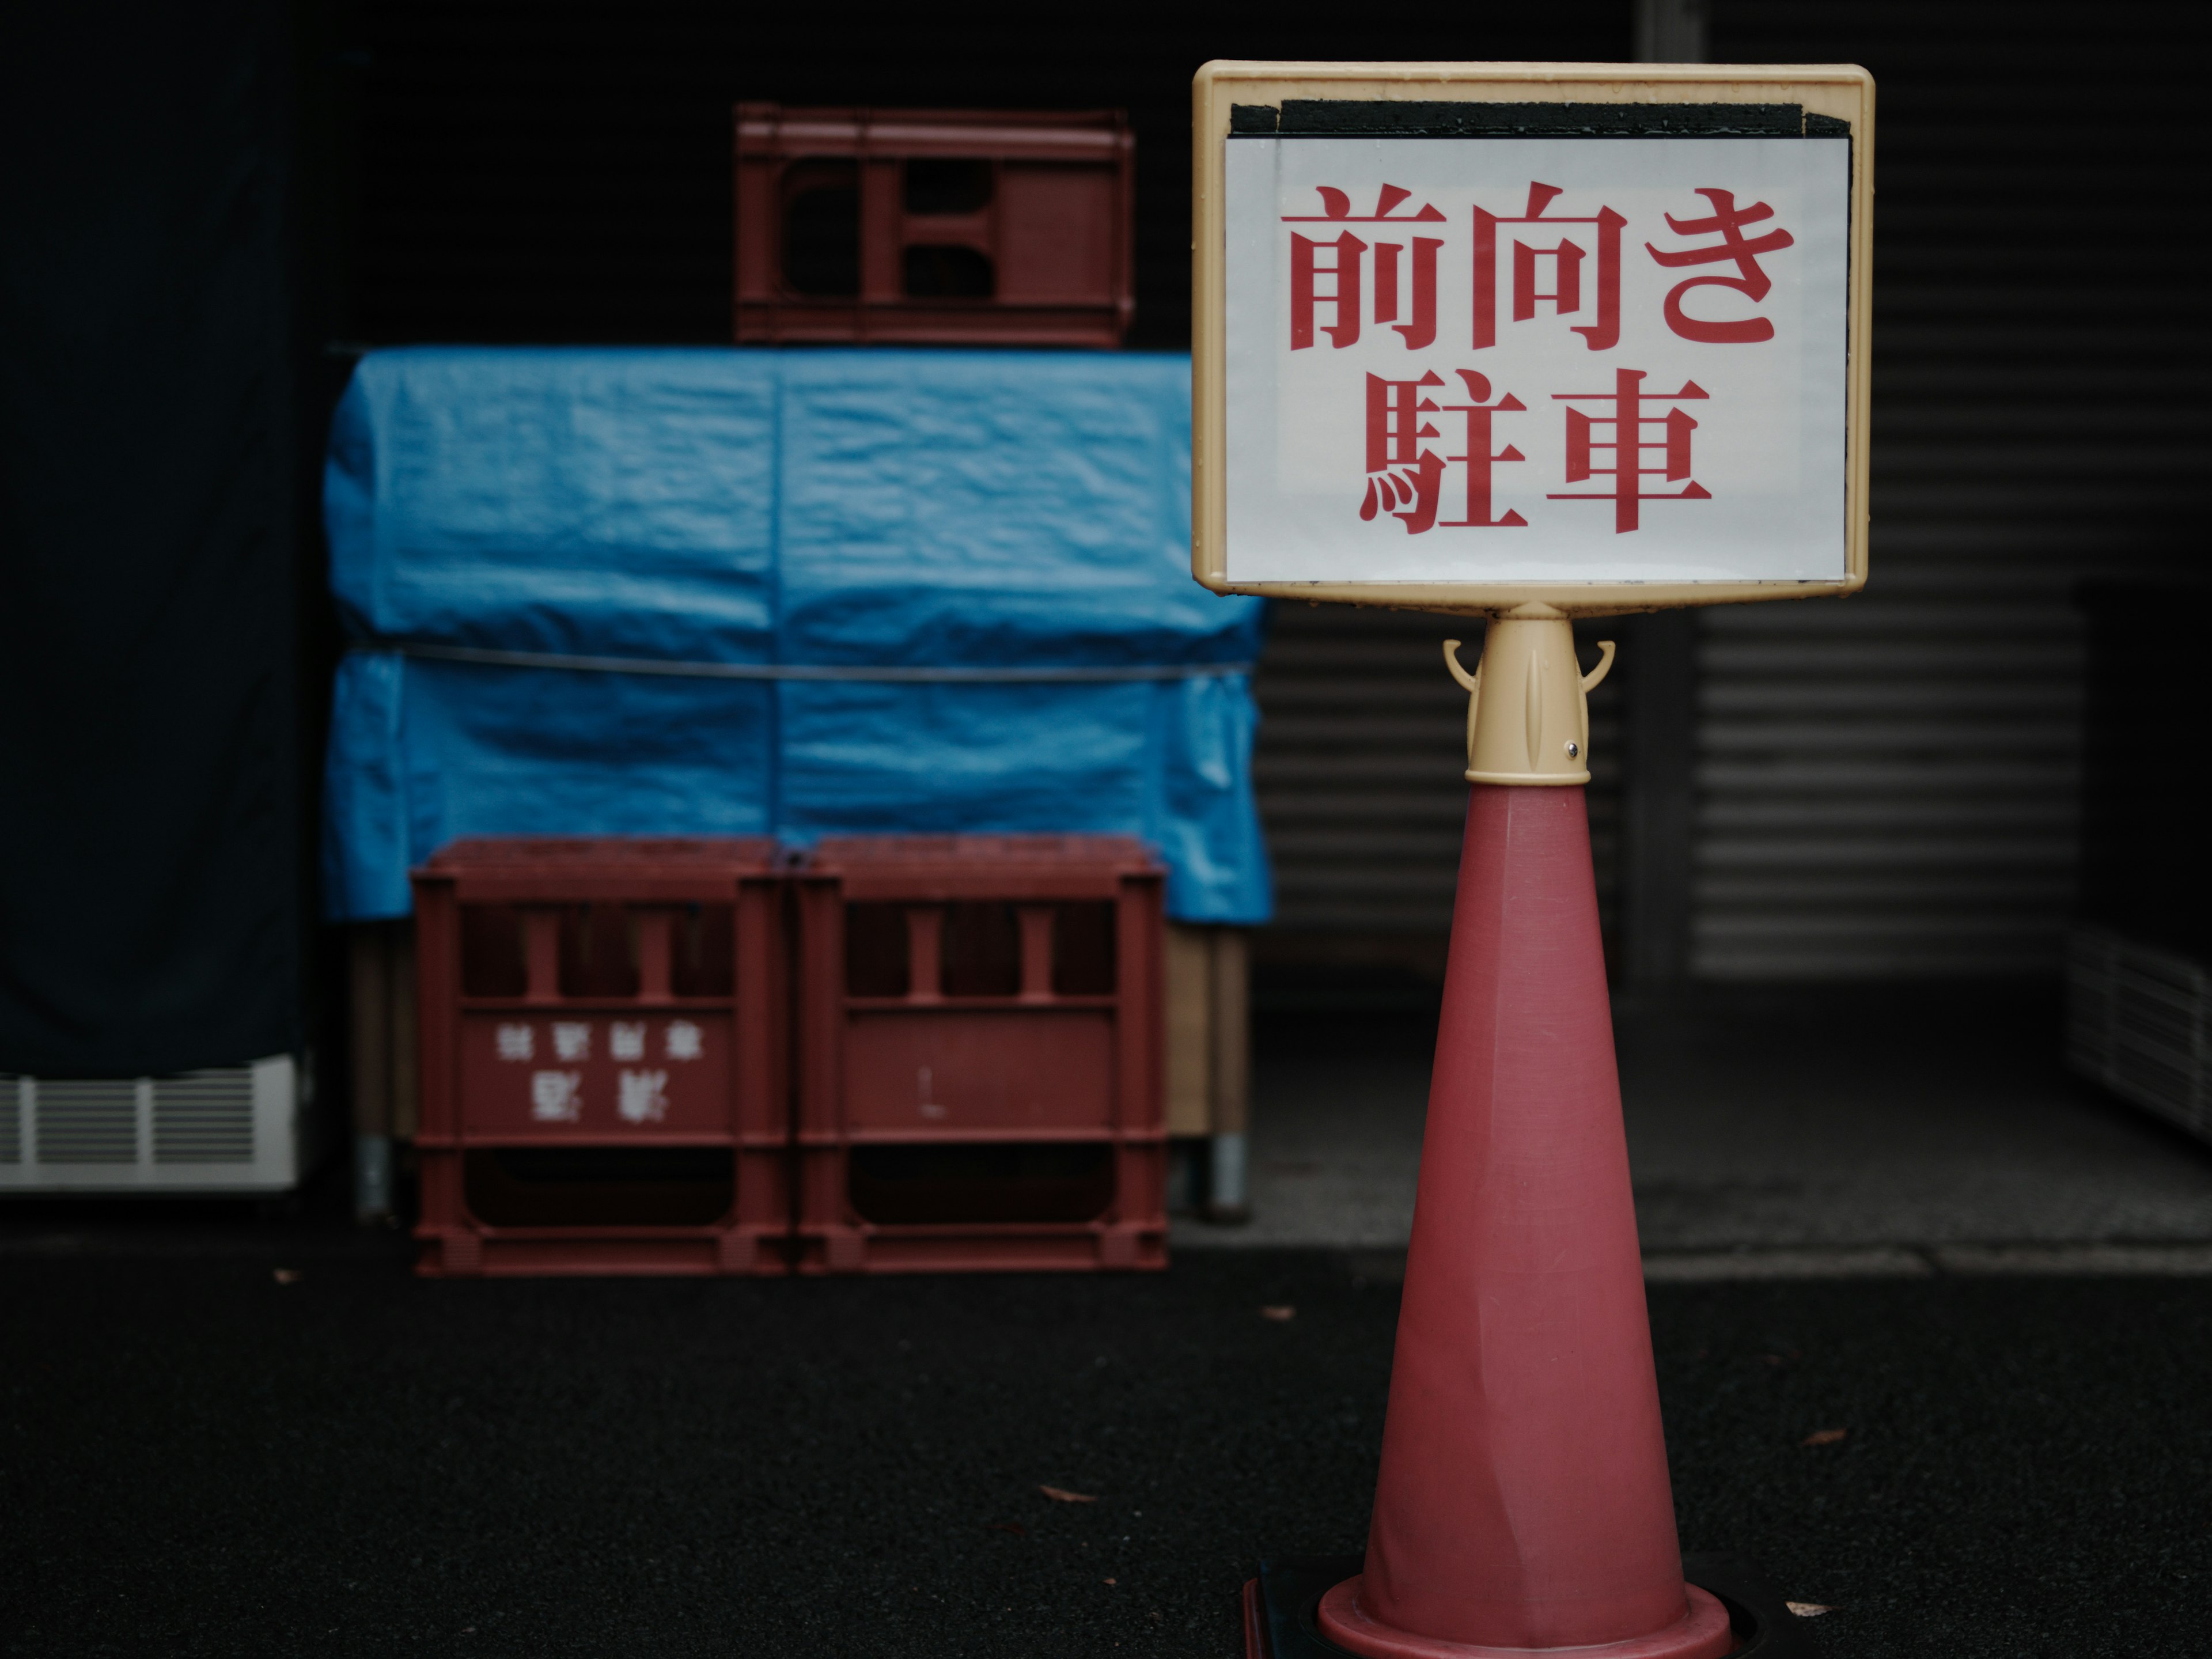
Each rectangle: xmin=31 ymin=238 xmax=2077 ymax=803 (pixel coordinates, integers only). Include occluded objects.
xmin=1192 ymin=62 xmax=1873 ymax=1659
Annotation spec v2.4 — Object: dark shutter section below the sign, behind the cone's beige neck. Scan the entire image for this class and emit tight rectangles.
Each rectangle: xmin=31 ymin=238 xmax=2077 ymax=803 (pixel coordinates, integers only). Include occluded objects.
xmin=1254 ymin=604 xmax=1619 ymax=933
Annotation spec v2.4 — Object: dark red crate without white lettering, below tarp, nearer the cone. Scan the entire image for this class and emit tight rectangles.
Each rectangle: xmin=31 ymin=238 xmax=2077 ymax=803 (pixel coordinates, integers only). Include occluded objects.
xmin=798 ymin=836 xmax=1168 ymax=1272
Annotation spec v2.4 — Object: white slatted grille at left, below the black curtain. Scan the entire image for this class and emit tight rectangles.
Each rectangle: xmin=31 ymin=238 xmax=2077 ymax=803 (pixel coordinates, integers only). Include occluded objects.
xmin=0 ymin=1055 xmax=312 ymax=1192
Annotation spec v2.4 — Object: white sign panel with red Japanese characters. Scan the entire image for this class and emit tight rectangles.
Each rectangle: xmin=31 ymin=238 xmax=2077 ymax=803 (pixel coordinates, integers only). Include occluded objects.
xmin=1221 ymin=135 xmax=1851 ymax=586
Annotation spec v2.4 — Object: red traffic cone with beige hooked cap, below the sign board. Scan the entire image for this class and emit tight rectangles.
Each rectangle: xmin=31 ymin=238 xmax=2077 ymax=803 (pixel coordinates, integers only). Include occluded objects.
xmin=1316 ymin=619 xmax=1734 ymax=1659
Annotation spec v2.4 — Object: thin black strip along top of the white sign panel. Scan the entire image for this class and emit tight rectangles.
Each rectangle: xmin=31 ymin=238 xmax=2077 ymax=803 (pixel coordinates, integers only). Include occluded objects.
xmin=1230 ymin=97 xmax=1851 ymax=137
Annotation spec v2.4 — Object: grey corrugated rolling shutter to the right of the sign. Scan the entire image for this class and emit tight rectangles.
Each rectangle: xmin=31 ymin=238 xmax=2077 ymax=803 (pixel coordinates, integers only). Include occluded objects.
xmin=1690 ymin=0 xmax=2212 ymax=980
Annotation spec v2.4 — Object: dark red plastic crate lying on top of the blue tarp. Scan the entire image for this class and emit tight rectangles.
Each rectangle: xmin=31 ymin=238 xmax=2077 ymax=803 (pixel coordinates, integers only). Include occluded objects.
xmin=734 ymin=104 xmax=1135 ymax=345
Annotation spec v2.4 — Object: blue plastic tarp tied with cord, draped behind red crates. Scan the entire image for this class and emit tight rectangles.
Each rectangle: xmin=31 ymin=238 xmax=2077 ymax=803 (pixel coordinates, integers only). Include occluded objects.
xmin=323 ymin=347 xmax=1270 ymax=922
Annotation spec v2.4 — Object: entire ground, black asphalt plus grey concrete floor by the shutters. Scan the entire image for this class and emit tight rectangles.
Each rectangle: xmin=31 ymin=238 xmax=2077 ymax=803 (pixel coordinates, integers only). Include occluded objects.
xmin=0 ymin=998 xmax=2212 ymax=1659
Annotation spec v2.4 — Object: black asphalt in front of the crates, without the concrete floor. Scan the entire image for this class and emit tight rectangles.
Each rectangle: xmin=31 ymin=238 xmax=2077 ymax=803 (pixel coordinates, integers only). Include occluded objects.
xmin=0 ymin=1224 xmax=2212 ymax=1659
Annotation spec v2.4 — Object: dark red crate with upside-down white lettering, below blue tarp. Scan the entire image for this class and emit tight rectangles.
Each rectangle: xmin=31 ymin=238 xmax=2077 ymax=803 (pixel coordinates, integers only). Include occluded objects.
xmin=414 ymin=836 xmax=792 ymax=1274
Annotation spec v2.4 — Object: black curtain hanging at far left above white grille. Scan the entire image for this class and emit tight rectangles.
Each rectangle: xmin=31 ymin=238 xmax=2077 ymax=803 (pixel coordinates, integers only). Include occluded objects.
xmin=0 ymin=0 xmax=303 ymax=1077
